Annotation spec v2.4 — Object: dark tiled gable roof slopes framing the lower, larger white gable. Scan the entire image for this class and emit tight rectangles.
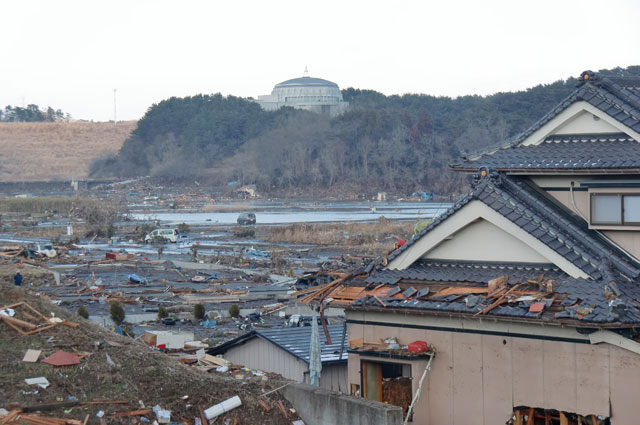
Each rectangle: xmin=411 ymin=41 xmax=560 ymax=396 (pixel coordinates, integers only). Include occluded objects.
xmin=388 ymin=174 xmax=640 ymax=279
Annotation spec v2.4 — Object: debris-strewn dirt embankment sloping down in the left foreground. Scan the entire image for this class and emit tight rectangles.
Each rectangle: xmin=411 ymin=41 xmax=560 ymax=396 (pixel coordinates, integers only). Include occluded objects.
xmin=0 ymin=263 xmax=291 ymax=424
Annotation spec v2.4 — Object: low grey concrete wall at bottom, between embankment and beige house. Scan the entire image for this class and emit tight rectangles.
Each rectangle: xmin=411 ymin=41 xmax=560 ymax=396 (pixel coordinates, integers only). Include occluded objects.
xmin=282 ymin=384 xmax=402 ymax=425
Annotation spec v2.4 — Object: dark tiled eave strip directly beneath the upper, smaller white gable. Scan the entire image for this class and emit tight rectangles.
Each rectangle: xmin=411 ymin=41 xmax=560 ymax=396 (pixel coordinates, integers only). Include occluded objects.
xmin=451 ymin=134 xmax=640 ymax=171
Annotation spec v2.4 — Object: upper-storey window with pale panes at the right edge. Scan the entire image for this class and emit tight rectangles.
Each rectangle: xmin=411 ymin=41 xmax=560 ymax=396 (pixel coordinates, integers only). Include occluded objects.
xmin=591 ymin=193 xmax=640 ymax=226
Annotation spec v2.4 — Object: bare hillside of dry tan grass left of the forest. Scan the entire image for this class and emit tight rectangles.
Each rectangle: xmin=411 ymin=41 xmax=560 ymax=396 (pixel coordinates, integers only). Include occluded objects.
xmin=0 ymin=121 xmax=137 ymax=182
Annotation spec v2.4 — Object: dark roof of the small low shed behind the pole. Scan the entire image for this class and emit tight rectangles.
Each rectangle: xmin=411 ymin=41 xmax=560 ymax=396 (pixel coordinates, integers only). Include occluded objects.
xmin=208 ymin=324 xmax=349 ymax=364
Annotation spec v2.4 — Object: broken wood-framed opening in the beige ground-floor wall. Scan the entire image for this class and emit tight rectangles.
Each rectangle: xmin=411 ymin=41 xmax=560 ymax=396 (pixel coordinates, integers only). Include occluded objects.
xmin=362 ymin=361 xmax=412 ymax=415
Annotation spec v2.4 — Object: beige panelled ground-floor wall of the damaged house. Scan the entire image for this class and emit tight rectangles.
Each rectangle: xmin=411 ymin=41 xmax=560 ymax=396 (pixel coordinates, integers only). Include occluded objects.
xmin=348 ymin=315 xmax=640 ymax=425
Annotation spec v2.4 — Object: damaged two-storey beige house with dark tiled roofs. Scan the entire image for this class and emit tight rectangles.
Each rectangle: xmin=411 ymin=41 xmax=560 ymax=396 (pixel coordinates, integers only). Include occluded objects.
xmin=315 ymin=71 xmax=640 ymax=425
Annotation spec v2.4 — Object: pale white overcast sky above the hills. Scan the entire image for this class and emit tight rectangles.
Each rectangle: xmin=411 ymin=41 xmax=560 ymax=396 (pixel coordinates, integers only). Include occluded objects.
xmin=0 ymin=0 xmax=640 ymax=121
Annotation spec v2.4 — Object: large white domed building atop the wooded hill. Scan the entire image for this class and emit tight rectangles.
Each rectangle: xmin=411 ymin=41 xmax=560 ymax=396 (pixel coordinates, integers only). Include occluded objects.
xmin=257 ymin=68 xmax=349 ymax=116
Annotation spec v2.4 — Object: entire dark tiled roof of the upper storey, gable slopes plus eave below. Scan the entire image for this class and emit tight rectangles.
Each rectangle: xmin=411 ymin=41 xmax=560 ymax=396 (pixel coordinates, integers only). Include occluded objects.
xmin=452 ymin=71 xmax=640 ymax=170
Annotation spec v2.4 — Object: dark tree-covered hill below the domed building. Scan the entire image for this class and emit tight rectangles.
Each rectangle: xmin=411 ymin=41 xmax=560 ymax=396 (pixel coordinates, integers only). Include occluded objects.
xmin=92 ymin=66 xmax=640 ymax=193
